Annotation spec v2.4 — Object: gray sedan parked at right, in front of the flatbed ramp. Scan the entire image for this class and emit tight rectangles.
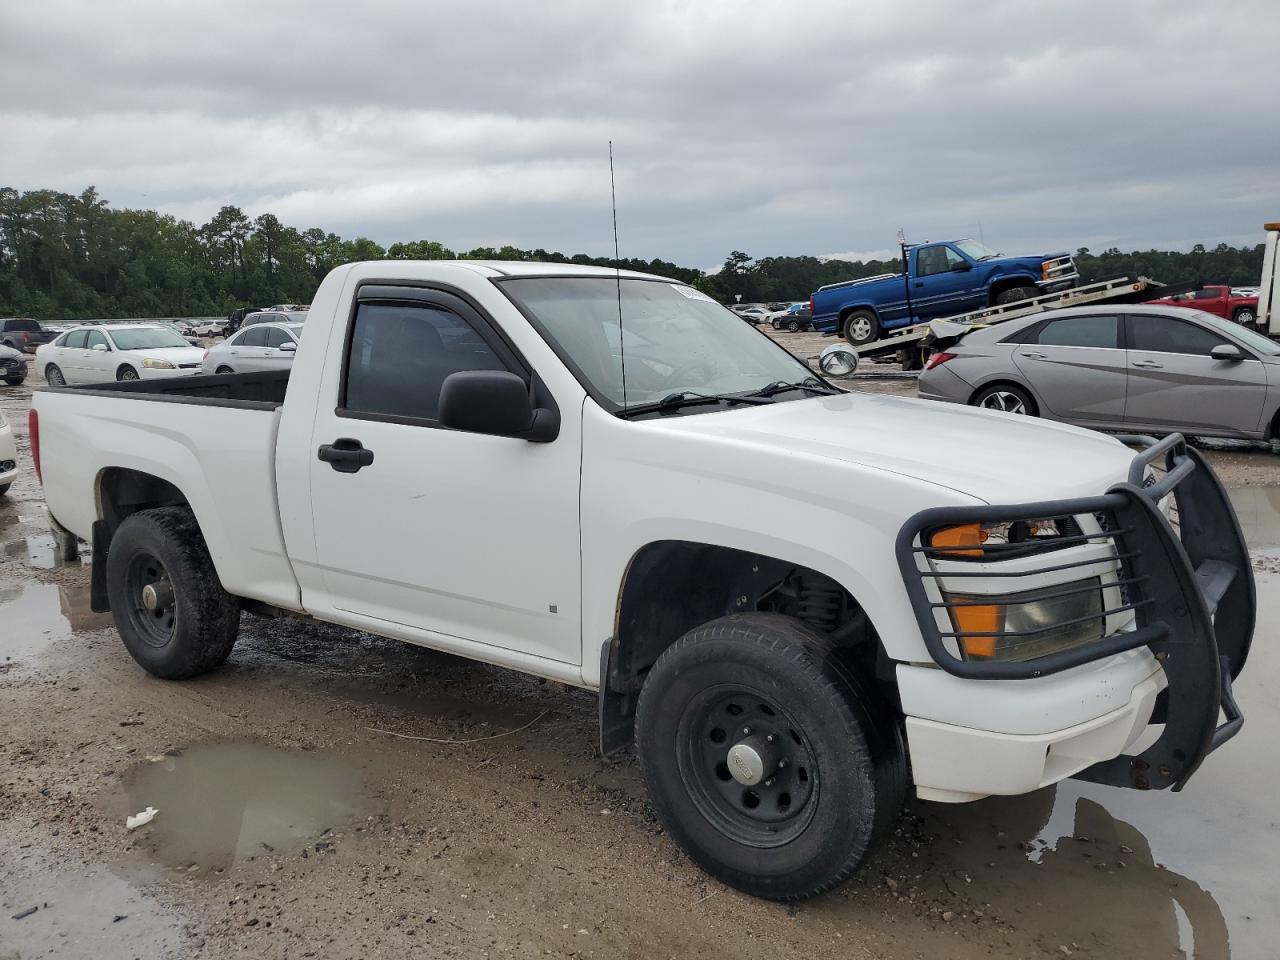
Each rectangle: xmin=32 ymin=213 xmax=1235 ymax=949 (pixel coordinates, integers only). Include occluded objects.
xmin=920 ymin=305 xmax=1280 ymax=440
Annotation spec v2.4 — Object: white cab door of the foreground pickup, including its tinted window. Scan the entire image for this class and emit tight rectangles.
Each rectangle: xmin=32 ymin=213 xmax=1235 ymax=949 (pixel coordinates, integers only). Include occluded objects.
xmin=306 ymin=287 xmax=582 ymax=664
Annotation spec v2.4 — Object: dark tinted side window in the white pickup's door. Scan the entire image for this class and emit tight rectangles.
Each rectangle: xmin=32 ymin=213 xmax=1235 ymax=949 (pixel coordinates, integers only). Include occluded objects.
xmin=340 ymin=303 xmax=507 ymax=420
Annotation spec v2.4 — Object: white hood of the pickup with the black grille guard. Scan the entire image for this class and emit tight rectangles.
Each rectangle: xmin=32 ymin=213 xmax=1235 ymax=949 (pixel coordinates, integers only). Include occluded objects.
xmin=663 ymin=393 xmax=1134 ymax=503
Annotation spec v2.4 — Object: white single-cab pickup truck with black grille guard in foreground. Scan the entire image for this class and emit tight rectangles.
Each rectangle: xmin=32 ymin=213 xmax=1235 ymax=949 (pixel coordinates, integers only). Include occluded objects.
xmin=31 ymin=262 xmax=1254 ymax=900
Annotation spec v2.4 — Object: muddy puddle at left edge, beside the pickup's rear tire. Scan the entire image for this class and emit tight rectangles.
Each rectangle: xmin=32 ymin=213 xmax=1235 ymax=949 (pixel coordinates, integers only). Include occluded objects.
xmin=0 ymin=582 xmax=111 ymax=672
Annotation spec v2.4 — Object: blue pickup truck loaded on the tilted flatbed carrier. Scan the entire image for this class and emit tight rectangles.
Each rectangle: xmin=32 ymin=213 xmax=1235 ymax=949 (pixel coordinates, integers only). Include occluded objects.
xmin=809 ymin=239 xmax=1079 ymax=347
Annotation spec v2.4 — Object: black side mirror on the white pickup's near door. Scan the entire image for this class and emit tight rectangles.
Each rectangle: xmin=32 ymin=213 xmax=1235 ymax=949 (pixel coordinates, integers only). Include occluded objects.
xmin=439 ymin=370 xmax=559 ymax=443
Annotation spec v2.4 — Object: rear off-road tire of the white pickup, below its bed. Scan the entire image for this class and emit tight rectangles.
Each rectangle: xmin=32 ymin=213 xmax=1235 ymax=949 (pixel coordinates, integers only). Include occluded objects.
xmin=106 ymin=507 xmax=239 ymax=680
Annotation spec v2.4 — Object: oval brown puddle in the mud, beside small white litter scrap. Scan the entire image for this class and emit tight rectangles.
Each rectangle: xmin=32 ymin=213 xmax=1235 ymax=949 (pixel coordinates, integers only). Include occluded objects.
xmin=120 ymin=744 xmax=371 ymax=872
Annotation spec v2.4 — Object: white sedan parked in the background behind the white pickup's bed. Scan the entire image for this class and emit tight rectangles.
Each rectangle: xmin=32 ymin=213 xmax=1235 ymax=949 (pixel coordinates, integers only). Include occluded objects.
xmin=36 ymin=324 xmax=204 ymax=387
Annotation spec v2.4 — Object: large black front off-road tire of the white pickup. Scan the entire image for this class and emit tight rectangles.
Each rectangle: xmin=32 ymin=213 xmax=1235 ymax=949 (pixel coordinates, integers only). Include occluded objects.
xmin=636 ymin=613 xmax=906 ymax=900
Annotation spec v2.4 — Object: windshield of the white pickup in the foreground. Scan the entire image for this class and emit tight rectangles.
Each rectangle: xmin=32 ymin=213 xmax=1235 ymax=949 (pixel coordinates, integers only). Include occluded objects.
xmin=500 ymin=276 xmax=817 ymax=411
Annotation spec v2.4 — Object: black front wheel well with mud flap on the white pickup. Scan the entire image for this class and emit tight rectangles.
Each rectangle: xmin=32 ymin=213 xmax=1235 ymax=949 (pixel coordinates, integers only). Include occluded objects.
xmin=600 ymin=540 xmax=892 ymax=754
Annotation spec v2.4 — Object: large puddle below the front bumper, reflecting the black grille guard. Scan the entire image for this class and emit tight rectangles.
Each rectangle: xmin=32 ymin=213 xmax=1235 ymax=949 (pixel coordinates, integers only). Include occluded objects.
xmin=896 ymin=575 xmax=1280 ymax=960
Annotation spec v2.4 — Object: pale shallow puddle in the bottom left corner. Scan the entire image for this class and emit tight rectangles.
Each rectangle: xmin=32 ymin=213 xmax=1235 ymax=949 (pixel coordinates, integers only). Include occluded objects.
xmin=0 ymin=868 xmax=182 ymax=960
